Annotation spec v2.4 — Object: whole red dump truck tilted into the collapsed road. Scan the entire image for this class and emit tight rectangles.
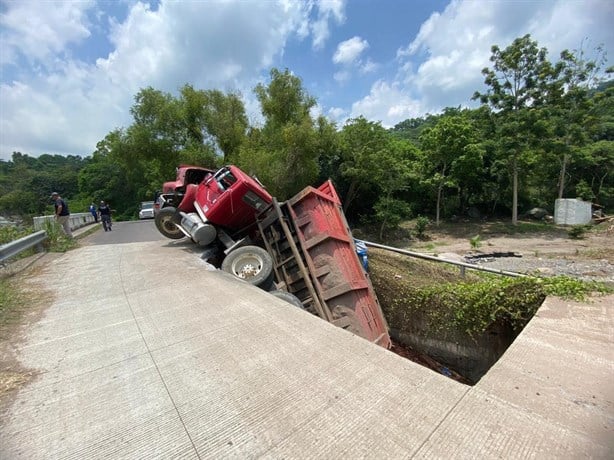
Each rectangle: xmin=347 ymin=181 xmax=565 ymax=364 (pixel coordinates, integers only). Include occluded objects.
xmin=155 ymin=165 xmax=391 ymax=348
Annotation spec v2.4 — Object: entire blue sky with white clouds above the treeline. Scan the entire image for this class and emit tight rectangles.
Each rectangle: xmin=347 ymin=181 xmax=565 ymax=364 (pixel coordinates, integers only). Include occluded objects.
xmin=0 ymin=0 xmax=614 ymax=160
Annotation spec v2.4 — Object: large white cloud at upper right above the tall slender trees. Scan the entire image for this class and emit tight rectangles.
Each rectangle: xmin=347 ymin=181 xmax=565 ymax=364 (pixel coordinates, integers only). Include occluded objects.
xmin=352 ymin=0 xmax=614 ymax=124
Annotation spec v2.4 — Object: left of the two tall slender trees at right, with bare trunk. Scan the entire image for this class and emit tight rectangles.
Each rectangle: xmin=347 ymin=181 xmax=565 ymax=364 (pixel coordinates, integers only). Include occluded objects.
xmin=473 ymin=35 xmax=553 ymax=225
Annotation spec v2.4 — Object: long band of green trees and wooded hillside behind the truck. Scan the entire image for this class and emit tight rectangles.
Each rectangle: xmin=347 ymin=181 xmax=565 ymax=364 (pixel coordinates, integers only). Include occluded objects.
xmin=0 ymin=35 xmax=614 ymax=235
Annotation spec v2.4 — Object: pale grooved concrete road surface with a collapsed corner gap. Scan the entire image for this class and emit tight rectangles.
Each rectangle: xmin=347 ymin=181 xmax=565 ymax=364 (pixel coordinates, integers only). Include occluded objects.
xmin=0 ymin=235 xmax=614 ymax=459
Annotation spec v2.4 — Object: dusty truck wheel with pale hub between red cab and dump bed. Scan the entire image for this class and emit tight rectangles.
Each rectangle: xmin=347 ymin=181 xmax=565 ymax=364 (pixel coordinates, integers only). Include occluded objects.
xmin=222 ymin=246 xmax=273 ymax=289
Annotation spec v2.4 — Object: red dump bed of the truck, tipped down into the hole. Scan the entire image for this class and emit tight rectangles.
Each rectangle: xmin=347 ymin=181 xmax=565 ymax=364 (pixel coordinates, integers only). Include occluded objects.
xmin=258 ymin=181 xmax=390 ymax=348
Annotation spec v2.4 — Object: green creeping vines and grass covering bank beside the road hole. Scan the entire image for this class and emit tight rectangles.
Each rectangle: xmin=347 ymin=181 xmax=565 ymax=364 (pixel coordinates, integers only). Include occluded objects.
xmin=369 ymin=249 xmax=613 ymax=338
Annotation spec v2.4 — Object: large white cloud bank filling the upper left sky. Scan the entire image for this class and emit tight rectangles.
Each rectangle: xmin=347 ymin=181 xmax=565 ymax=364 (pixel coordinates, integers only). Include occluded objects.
xmin=0 ymin=0 xmax=345 ymax=159
